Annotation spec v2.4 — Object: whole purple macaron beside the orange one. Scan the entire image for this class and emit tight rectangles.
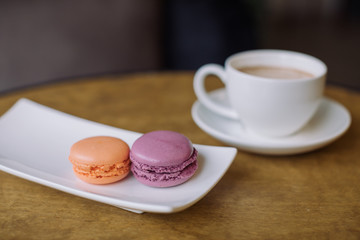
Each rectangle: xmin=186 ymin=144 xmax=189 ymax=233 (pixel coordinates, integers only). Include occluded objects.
xmin=130 ymin=131 xmax=198 ymax=187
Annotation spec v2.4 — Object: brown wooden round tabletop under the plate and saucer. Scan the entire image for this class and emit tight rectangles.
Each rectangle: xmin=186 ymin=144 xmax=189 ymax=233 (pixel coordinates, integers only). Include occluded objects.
xmin=0 ymin=72 xmax=360 ymax=239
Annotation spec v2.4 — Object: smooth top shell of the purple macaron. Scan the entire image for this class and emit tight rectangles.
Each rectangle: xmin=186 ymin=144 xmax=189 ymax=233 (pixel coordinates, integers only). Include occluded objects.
xmin=131 ymin=131 xmax=193 ymax=166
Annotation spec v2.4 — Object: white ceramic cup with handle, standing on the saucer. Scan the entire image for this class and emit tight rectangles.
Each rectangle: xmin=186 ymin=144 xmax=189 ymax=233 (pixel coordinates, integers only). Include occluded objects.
xmin=194 ymin=50 xmax=327 ymax=137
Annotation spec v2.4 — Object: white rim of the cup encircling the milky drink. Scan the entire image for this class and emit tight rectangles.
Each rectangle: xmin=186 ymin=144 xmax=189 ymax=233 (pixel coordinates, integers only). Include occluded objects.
xmin=225 ymin=49 xmax=328 ymax=82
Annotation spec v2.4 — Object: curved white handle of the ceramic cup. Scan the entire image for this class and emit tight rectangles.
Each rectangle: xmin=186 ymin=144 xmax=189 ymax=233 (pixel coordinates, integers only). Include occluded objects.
xmin=194 ymin=63 xmax=239 ymax=119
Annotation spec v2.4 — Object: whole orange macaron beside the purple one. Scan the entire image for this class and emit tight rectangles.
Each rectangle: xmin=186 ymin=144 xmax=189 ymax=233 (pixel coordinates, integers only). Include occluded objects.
xmin=69 ymin=136 xmax=130 ymax=184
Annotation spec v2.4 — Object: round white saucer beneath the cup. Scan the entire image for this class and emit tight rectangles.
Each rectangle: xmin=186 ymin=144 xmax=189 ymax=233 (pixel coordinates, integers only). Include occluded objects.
xmin=191 ymin=89 xmax=351 ymax=155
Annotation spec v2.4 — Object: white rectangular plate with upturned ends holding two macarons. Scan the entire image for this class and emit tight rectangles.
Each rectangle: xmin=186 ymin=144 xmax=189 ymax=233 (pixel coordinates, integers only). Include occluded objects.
xmin=0 ymin=99 xmax=237 ymax=213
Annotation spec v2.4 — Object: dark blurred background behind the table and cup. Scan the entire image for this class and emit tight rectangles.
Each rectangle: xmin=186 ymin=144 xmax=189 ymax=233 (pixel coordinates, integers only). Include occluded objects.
xmin=0 ymin=0 xmax=360 ymax=92
